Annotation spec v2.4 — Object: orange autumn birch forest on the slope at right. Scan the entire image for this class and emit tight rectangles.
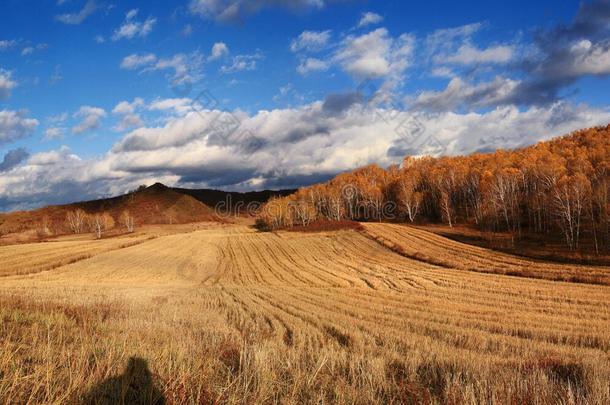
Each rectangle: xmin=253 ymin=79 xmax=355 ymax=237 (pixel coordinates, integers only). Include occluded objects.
xmin=257 ymin=125 xmax=610 ymax=253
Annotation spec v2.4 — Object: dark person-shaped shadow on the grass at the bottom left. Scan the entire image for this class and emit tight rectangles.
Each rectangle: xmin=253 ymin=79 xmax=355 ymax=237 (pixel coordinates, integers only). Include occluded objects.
xmin=81 ymin=357 xmax=165 ymax=405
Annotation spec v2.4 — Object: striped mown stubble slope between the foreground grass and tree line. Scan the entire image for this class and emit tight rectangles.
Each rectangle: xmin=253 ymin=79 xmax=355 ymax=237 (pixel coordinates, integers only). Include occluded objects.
xmin=1 ymin=224 xmax=610 ymax=370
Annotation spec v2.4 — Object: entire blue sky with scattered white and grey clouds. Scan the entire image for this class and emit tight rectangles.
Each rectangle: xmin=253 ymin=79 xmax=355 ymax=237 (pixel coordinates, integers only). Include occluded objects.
xmin=0 ymin=0 xmax=610 ymax=211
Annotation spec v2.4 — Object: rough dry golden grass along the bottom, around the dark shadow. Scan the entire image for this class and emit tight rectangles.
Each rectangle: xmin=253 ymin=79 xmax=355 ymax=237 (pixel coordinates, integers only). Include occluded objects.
xmin=0 ymin=292 xmax=610 ymax=404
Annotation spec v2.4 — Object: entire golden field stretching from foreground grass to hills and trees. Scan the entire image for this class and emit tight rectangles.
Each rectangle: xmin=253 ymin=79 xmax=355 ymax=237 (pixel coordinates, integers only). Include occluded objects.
xmin=0 ymin=224 xmax=610 ymax=404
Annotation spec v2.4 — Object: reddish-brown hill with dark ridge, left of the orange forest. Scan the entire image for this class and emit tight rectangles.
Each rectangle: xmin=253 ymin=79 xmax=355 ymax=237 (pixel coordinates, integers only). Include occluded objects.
xmin=0 ymin=183 xmax=293 ymax=240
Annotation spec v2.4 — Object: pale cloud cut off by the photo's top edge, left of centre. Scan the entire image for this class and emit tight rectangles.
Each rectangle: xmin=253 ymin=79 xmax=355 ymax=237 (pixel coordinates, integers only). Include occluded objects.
xmin=189 ymin=0 xmax=328 ymax=22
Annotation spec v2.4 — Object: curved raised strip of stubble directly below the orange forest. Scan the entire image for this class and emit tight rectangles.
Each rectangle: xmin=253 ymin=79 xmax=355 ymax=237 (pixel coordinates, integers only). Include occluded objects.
xmin=363 ymin=223 xmax=610 ymax=285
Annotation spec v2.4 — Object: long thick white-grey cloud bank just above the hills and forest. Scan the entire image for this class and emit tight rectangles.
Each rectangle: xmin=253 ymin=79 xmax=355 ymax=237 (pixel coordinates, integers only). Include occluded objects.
xmin=0 ymin=100 xmax=610 ymax=209
